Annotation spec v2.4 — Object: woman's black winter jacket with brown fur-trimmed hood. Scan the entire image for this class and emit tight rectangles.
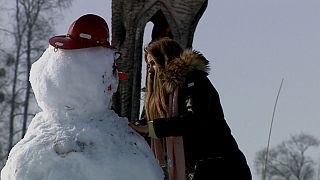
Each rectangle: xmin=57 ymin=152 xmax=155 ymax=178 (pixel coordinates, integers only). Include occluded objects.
xmin=149 ymin=50 xmax=251 ymax=180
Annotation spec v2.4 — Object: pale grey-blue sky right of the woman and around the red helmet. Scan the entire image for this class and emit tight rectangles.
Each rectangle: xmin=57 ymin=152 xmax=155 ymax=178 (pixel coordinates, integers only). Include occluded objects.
xmin=57 ymin=0 xmax=320 ymax=179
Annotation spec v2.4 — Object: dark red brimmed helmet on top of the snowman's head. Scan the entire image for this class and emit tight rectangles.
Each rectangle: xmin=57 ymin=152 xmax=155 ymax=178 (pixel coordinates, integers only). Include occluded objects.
xmin=49 ymin=14 xmax=115 ymax=49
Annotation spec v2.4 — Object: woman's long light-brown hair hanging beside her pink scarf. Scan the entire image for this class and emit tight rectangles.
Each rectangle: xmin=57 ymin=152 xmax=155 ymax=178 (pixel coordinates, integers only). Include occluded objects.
xmin=144 ymin=38 xmax=183 ymax=120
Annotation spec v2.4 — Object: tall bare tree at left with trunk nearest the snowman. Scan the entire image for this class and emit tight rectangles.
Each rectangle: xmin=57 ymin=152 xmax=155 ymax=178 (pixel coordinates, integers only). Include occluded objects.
xmin=16 ymin=0 xmax=70 ymax=137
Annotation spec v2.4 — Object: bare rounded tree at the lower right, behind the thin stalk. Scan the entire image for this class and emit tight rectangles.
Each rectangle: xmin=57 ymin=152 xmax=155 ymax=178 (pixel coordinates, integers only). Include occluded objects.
xmin=255 ymin=133 xmax=320 ymax=180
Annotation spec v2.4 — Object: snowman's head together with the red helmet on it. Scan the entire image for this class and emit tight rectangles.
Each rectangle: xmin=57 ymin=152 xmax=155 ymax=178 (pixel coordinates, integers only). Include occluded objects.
xmin=30 ymin=14 xmax=127 ymax=115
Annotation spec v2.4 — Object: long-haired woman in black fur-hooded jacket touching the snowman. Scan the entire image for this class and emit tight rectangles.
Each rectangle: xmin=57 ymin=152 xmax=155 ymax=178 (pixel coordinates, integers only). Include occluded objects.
xmin=130 ymin=38 xmax=251 ymax=180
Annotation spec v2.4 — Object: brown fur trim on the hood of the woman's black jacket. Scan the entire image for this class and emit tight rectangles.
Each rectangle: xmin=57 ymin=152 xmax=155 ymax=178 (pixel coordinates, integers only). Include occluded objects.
xmin=160 ymin=49 xmax=210 ymax=92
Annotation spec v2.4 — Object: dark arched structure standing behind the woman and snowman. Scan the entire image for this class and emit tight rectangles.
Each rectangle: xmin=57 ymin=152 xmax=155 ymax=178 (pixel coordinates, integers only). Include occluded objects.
xmin=111 ymin=0 xmax=208 ymax=121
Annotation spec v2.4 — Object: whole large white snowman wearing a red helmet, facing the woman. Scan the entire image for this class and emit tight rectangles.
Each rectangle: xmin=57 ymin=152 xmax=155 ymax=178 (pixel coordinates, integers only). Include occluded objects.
xmin=1 ymin=14 xmax=164 ymax=180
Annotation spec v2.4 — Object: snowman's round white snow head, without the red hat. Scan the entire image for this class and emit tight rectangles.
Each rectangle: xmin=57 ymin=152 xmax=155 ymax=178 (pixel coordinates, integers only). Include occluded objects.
xmin=30 ymin=46 xmax=124 ymax=114
